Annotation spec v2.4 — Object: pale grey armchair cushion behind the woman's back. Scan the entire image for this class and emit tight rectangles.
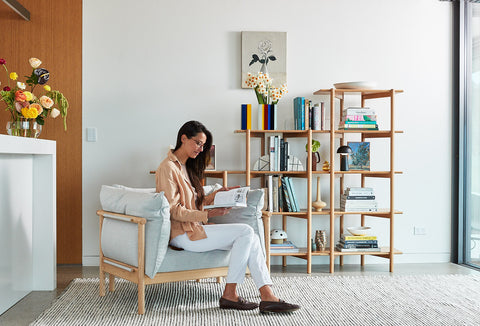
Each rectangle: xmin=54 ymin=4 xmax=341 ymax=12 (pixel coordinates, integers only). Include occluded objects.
xmin=100 ymin=186 xmax=170 ymax=278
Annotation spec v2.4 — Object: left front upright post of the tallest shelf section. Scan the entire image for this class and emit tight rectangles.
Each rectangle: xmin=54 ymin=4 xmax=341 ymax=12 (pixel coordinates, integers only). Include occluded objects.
xmin=330 ymin=88 xmax=336 ymax=273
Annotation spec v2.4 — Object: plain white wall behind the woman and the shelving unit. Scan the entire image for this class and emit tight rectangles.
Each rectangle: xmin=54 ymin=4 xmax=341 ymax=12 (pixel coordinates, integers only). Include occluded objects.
xmin=83 ymin=0 xmax=452 ymax=264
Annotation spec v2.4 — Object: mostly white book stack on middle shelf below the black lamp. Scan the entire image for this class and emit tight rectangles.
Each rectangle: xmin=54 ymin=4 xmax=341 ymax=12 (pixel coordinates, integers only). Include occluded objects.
xmin=340 ymin=187 xmax=378 ymax=212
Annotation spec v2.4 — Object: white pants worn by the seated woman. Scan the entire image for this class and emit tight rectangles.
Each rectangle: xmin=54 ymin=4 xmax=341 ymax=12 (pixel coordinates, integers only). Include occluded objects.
xmin=170 ymin=224 xmax=272 ymax=288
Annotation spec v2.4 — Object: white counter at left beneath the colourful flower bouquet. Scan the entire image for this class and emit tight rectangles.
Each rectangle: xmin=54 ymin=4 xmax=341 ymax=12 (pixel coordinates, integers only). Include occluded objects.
xmin=0 ymin=135 xmax=57 ymax=314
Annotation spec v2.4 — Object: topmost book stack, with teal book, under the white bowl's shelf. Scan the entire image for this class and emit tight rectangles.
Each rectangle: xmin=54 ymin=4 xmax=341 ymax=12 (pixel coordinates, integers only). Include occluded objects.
xmin=338 ymin=107 xmax=378 ymax=130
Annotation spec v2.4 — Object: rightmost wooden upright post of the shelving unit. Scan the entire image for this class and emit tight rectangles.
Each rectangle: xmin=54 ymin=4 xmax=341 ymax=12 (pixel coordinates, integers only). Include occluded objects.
xmin=390 ymin=89 xmax=395 ymax=273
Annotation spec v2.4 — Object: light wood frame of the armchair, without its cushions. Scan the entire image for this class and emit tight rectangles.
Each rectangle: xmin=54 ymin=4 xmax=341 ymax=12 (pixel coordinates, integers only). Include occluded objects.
xmin=97 ymin=210 xmax=270 ymax=315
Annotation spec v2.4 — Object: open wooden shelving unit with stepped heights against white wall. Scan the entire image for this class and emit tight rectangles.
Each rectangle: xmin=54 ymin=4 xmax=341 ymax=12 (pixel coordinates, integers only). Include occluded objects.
xmin=228 ymin=88 xmax=403 ymax=273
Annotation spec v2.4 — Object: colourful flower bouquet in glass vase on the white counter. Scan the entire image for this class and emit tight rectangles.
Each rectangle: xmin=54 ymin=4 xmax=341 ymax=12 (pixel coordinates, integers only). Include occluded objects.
xmin=0 ymin=58 xmax=68 ymax=138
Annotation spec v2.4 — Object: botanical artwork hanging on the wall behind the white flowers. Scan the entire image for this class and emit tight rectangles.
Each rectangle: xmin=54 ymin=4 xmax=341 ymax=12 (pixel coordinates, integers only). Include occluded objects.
xmin=242 ymin=32 xmax=287 ymax=88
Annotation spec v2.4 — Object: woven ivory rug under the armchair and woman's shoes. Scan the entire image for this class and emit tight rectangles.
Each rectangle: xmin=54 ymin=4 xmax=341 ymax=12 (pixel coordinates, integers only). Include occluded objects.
xmin=31 ymin=275 xmax=480 ymax=326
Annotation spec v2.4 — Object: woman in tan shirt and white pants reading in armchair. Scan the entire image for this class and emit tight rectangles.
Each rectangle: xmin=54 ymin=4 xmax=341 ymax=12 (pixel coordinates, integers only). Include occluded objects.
xmin=156 ymin=121 xmax=300 ymax=313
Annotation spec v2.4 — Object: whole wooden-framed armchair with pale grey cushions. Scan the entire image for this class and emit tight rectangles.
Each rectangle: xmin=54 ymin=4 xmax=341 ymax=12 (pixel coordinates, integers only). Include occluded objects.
xmin=97 ymin=186 xmax=269 ymax=314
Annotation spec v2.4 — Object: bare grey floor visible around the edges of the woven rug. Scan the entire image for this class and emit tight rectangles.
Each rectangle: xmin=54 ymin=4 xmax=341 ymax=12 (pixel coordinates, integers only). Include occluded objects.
xmin=0 ymin=263 xmax=480 ymax=326
